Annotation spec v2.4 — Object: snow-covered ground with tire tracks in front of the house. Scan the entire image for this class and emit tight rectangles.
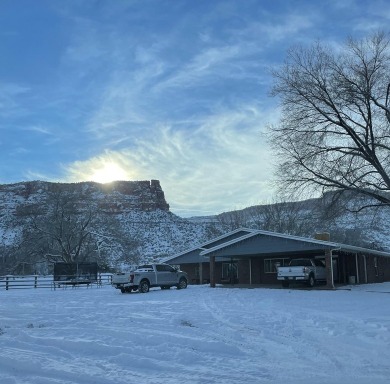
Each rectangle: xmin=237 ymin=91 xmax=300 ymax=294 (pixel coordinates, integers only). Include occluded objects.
xmin=0 ymin=283 xmax=390 ymax=384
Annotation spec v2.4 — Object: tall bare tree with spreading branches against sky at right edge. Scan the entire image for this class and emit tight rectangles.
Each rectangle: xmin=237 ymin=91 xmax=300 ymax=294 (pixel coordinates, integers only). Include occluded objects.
xmin=270 ymin=33 xmax=390 ymax=207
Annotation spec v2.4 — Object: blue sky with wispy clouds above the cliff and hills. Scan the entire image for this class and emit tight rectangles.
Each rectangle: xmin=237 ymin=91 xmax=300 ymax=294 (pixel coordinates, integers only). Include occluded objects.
xmin=0 ymin=0 xmax=390 ymax=217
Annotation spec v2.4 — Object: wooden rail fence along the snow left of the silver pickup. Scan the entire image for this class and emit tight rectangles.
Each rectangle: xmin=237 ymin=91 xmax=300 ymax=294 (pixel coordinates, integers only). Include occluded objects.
xmin=0 ymin=273 xmax=112 ymax=291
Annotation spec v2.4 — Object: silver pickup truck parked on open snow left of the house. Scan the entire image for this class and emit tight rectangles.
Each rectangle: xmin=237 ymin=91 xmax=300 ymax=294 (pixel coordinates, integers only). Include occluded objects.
xmin=111 ymin=264 xmax=188 ymax=293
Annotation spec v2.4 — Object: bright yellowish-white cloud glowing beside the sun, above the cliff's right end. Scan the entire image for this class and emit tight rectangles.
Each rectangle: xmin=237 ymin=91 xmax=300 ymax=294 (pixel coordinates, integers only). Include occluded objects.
xmin=65 ymin=105 xmax=275 ymax=216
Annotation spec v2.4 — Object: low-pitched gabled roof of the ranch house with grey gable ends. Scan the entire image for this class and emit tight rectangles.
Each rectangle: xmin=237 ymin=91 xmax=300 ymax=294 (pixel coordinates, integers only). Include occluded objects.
xmin=165 ymin=228 xmax=390 ymax=264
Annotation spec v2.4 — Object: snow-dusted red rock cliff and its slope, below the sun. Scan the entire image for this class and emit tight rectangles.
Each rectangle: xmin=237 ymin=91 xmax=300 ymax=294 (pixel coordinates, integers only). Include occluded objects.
xmin=0 ymin=180 xmax=213 ymax=272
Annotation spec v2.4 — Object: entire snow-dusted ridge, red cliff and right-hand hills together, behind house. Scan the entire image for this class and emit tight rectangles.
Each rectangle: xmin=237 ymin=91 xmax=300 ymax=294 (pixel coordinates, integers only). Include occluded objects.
xmin=0 ymin=180 xmax=390 ymax=267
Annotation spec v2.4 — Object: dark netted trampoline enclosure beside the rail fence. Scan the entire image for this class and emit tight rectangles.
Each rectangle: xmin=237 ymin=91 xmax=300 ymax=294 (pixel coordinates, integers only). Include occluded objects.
xmin=54 ymin=262 xmax=98 ymax=285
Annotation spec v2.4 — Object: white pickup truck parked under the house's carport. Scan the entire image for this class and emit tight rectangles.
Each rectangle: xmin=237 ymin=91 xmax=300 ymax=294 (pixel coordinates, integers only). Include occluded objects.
xmin=277 ymin=259 xmax=326 ymax=287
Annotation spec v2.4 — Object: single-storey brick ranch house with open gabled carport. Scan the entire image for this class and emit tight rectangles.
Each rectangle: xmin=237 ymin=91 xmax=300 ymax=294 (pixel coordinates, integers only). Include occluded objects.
xmin=164 ymin=228 xmax=390 ymax=288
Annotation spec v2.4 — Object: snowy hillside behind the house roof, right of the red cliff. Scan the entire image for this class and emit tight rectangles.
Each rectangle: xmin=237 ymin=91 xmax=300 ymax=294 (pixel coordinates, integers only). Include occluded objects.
xmin=218 ymin=193 xmax=390 ymax=250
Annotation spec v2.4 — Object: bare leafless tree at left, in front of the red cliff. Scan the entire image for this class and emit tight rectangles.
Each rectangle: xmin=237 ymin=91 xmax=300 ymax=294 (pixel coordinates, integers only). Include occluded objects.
xmin=20 ymin=185 xmax=139 ymax=266
